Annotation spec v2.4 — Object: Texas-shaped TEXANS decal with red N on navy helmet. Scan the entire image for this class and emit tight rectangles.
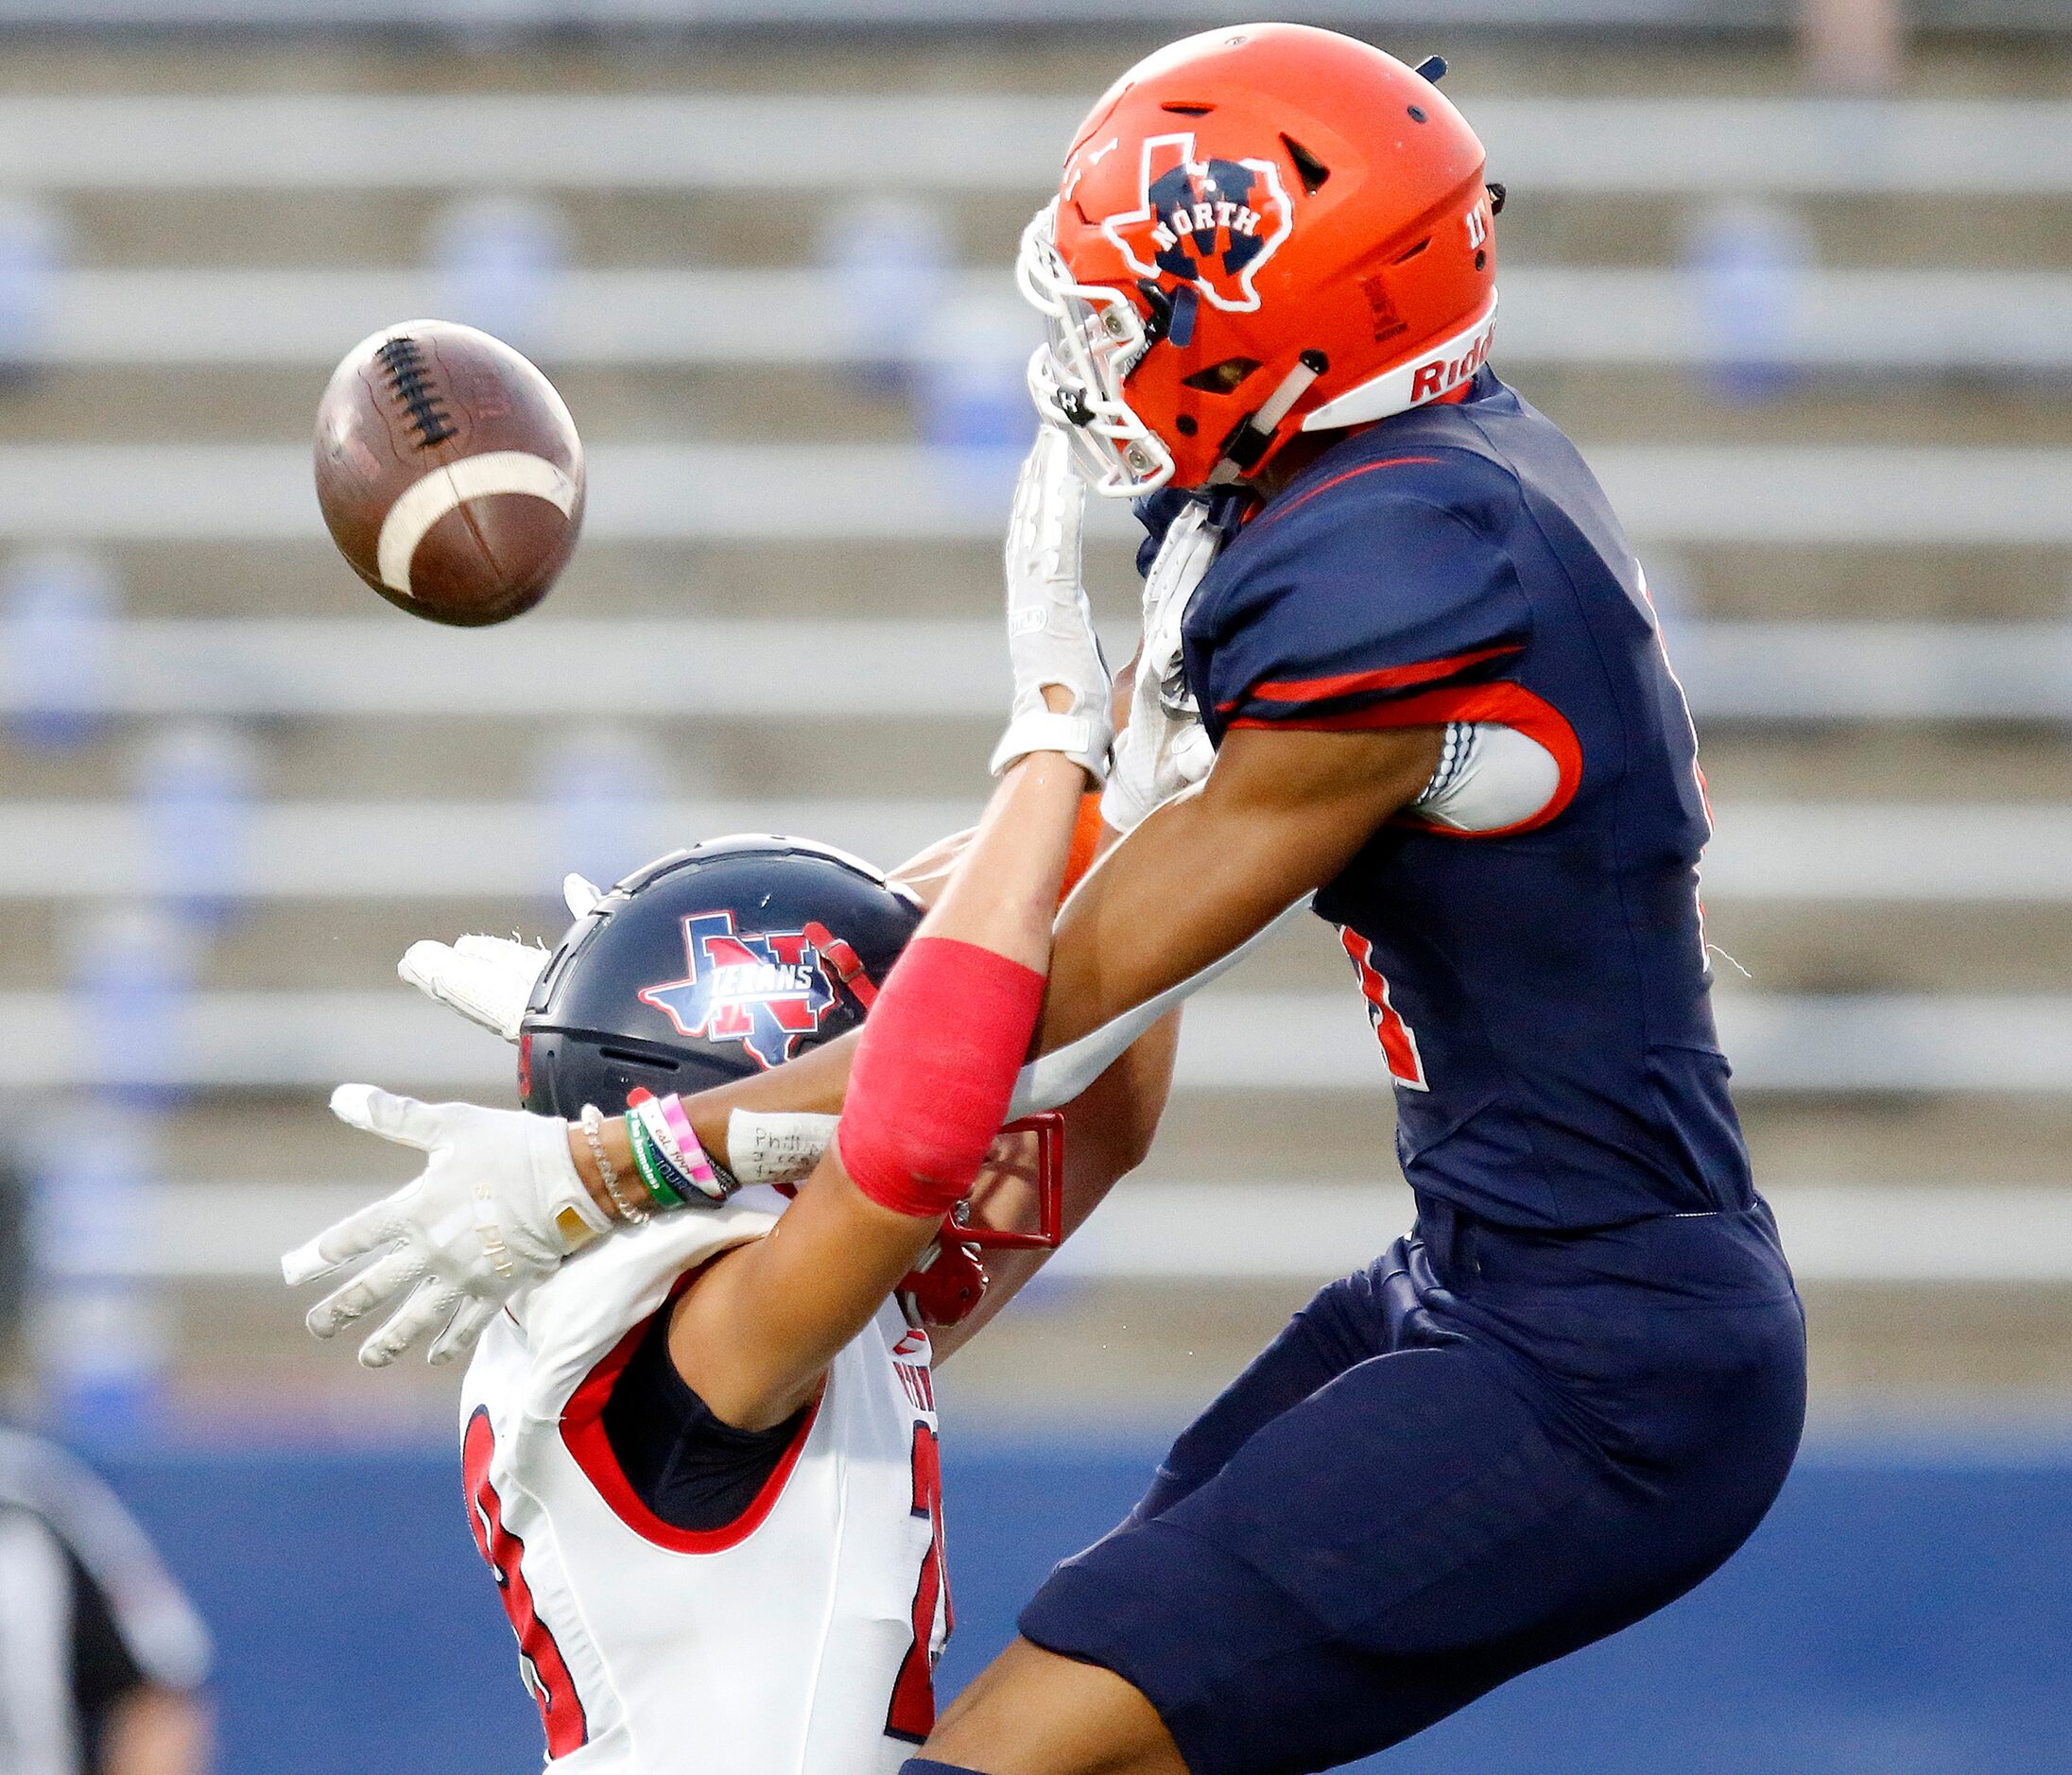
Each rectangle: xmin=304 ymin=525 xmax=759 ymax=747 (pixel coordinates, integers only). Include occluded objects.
xmin=640 ymin=911 xmax=837 ymax=1067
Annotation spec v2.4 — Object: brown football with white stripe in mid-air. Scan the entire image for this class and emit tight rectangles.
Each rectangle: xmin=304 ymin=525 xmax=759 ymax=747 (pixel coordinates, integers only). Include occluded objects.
xmin=317 ymin=321 xmax=582 ymax=628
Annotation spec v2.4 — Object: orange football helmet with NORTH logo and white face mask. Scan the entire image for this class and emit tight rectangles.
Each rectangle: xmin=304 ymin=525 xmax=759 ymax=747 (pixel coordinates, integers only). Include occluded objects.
xmin=1017 ymin=25 xmax=1502 ymax=497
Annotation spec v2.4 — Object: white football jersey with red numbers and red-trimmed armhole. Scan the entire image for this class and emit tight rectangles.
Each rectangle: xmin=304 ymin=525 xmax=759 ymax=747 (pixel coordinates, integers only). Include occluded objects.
xmin=460 ymin=1189 xmax=949 ymax=1775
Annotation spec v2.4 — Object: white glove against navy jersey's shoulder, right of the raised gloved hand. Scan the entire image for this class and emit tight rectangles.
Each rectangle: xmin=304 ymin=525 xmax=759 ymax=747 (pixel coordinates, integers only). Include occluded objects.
xmin=1100 ymin=504 xmax=1222 ymax=833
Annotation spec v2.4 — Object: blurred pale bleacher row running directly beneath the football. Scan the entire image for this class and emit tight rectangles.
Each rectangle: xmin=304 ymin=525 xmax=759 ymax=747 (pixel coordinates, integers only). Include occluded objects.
xmin=0 ymin=615 xmax=2072 ymax=716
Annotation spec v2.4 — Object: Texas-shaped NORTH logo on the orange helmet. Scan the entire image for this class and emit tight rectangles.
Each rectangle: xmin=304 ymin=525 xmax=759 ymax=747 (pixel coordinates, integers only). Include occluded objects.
xmin=1100 ymin=134 xmax=1295 ymax=315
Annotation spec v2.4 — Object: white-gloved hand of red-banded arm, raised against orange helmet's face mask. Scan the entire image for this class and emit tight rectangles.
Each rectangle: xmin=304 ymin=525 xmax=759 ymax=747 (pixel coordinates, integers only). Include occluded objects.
xmin=993 ymin=424 xmax=1111 ymax=783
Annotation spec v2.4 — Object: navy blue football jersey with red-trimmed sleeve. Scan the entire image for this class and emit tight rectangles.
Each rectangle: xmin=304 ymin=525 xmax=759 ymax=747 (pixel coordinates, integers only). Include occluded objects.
xmin=1146 ymin=371 xmax=1751 ymax=1226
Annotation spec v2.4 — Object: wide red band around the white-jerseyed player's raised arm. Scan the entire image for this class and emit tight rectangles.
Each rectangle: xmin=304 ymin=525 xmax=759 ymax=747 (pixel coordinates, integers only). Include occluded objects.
xmin=835 ymin=936 xmax=1045 ymax=1218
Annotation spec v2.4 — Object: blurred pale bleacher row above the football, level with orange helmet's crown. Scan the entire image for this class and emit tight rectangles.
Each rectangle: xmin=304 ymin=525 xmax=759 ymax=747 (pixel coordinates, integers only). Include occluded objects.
xmin=11 ymin=91 xmax=2072 ymax=197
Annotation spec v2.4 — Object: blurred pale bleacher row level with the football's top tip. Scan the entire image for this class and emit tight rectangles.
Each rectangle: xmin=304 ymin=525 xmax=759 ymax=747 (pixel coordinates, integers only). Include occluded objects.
xmin=26 ymin=261 xmax=2072 ymax=375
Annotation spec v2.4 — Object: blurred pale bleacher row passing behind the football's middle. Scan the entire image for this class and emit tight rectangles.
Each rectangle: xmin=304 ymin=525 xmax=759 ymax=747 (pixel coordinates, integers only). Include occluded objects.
xmin=0 ymin=443 xmax=2072 ymax=547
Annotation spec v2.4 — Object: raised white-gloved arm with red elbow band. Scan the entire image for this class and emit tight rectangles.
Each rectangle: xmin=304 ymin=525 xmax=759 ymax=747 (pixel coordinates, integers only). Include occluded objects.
xmin=605 ymin=431 xmax=1111 ymax=1429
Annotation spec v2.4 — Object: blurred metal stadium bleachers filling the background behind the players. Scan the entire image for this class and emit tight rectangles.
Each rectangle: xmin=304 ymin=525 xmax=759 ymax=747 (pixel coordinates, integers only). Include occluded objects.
xmin=0 ymin=20 xmax=2072 ymax=1410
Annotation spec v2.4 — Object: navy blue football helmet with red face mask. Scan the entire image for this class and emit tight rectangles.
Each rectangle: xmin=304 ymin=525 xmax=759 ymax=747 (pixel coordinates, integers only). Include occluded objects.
xmin=518 ymin=835 xmax=1062 ymax=1325
